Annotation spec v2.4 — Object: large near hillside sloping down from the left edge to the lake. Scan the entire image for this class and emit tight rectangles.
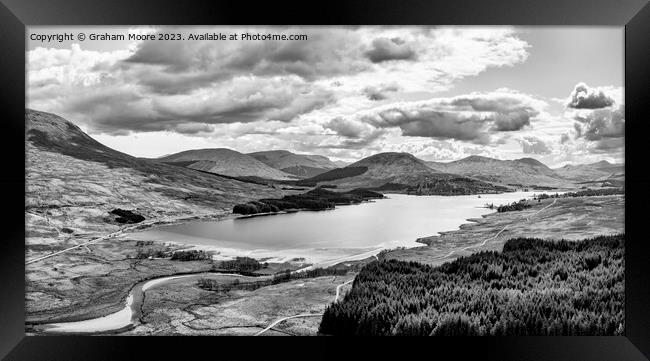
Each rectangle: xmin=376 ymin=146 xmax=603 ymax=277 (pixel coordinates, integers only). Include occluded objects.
xmin=25 ymin=109 xmax=280 ymax=239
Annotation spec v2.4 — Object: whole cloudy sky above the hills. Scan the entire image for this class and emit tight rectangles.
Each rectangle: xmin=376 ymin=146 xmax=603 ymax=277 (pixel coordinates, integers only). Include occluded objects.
xmin=26 ymin=26 xmax=625 ymax=167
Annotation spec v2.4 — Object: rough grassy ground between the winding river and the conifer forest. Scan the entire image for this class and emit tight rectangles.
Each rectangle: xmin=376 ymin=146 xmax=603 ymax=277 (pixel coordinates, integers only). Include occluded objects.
xmin=125 ymin=273 xmax=355 ymax=335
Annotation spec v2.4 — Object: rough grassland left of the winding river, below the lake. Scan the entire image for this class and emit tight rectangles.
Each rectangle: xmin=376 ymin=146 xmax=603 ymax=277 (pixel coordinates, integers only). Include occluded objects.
xmin=25 ymin=239 xmax=303 ymax=324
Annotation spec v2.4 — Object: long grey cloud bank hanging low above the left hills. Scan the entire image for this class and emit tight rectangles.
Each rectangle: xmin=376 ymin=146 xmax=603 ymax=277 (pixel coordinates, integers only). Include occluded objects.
xmin=53 ymin=74 xmax=334 ymax=133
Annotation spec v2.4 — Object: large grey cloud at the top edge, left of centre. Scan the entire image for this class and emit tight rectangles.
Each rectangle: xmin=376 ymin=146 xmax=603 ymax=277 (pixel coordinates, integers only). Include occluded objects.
xmin=122 ymin=27 xmax=370 ymax=93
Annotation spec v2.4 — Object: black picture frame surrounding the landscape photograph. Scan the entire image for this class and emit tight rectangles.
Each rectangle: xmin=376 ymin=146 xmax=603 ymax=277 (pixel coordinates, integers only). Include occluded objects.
xmin=0 ymin=0 xmax=650 ymax=361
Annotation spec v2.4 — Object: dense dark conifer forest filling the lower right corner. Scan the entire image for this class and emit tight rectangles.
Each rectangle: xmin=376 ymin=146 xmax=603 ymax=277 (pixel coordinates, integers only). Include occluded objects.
xmin=319 ymin=235 xmax=625 ymax=335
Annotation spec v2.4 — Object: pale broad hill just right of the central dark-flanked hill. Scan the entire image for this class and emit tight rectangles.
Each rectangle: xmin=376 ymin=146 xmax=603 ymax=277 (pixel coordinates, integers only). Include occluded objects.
xmin=425 ymin=155 xmax=573 ymax=187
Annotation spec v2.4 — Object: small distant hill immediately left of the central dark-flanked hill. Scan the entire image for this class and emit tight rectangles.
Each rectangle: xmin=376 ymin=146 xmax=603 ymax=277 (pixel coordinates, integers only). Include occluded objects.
xmin=248 ymin=150 xmax=338 ymax=178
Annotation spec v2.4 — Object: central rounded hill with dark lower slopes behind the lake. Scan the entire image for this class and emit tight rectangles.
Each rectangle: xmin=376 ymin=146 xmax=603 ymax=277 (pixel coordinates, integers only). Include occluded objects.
xmin=304 ymin=152 xmax=507 ymax=195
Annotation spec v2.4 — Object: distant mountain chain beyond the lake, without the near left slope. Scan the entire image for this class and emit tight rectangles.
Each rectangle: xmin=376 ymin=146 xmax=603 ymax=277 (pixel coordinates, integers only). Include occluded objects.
xmin=158 ymin=148 xmax=625 ymax=189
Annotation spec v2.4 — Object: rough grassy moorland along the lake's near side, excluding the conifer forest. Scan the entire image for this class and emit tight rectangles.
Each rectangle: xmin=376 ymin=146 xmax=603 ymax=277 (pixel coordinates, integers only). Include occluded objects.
xmin=26 ymin=195 xmax=624 ymax=335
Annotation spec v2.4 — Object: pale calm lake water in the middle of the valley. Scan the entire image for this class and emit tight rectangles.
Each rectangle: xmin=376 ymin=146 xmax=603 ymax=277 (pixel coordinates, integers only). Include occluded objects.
xmin=129 ymin=192 xmax=535 ymax=262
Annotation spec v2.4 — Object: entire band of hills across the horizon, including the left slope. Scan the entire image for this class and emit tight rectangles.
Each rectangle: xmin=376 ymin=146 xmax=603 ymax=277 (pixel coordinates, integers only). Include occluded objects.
xmin=25 ymin=110 xmax=625 ymax=222
